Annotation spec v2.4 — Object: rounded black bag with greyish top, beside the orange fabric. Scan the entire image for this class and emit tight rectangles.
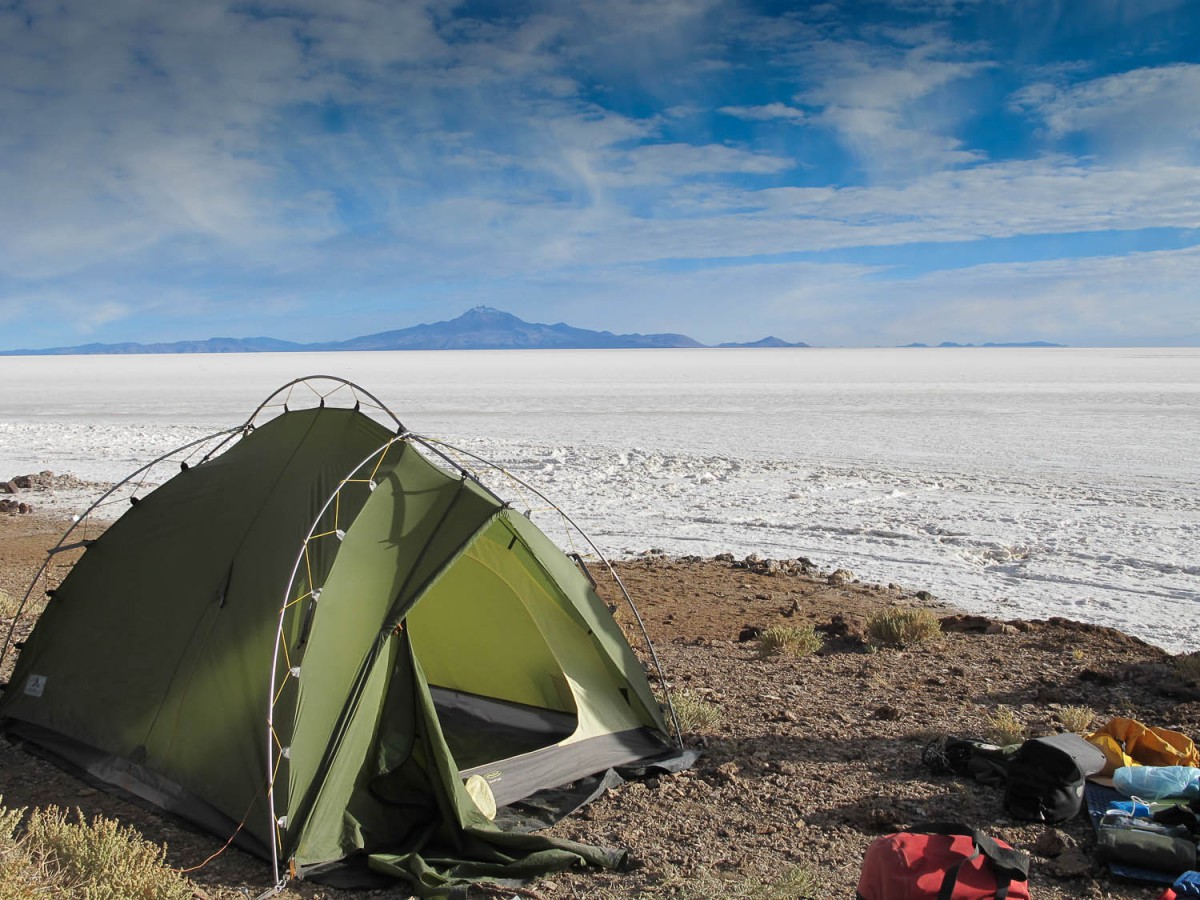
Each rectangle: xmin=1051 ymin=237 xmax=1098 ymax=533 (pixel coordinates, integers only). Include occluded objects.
xmin=1004 ymin=734 xmax=1104 ymax=822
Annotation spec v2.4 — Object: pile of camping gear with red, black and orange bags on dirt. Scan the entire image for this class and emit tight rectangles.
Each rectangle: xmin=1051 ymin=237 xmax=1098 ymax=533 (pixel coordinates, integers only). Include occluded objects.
xmin=902 ymin=718 xmax=1200 ymax=900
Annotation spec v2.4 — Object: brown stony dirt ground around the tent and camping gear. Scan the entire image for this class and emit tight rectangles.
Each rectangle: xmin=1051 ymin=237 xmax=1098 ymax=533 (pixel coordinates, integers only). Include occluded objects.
xmin=0 ymin=515 xmax=1200 ymax=900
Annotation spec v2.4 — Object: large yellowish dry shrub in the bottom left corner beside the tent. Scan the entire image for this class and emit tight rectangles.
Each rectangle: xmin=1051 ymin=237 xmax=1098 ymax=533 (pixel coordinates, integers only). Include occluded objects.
xmin=18 ymin=806 xmax=193 ymax=900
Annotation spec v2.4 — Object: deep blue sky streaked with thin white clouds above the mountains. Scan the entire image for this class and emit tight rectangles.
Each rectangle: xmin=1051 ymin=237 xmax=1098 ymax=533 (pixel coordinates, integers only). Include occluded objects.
xmin=0 ymin=0 xmax=1200 ymax=348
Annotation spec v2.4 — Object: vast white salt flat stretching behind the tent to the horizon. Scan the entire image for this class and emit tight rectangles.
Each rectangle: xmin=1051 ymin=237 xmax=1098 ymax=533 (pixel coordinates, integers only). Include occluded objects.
xmin=0 ymin=348 xmax=1200 ymax=650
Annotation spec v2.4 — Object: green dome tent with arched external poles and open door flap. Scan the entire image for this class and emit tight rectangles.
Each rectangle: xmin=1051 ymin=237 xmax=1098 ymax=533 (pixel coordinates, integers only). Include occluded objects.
xmin=0 ymin=377 xmax=678 ymax=892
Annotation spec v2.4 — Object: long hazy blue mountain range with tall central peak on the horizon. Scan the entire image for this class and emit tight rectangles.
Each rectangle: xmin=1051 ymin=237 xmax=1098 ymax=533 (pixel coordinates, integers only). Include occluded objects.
xmin=0 ymin=306 xmax=808 ymax=356
